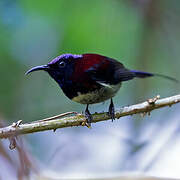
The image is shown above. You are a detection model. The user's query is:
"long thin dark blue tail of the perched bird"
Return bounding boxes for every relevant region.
[131,70,179,83]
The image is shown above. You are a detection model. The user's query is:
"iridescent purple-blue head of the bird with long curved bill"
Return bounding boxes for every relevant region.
[26,54,82,83]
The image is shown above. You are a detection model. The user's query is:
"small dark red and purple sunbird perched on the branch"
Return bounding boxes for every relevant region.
[26,54,177,124]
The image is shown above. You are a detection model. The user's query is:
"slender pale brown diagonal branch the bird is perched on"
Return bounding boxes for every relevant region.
[0,95,180,139]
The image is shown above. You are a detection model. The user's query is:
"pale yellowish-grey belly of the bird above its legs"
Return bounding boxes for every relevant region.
[72,83,121,104]
